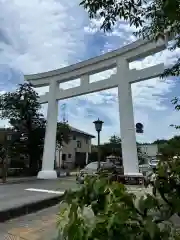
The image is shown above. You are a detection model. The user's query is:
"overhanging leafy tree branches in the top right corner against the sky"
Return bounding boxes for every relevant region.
[80,0,180,76]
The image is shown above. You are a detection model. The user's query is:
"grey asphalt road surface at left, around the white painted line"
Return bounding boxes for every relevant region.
[0,177,78,211]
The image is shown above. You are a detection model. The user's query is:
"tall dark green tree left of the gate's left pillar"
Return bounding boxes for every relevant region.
[0,83,46,175]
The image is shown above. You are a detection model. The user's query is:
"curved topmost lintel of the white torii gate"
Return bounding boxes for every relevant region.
[25,39,166,87]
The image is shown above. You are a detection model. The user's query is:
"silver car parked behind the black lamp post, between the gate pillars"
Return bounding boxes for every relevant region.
[76,162,116,183]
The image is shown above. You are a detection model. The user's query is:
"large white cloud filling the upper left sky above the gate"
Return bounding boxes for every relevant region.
[0,0,86,74]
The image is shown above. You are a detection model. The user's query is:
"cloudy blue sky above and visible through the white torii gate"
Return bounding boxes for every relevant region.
[0,0,180,142]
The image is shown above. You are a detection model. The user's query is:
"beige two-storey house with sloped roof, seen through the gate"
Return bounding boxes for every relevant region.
[56,127,95,169]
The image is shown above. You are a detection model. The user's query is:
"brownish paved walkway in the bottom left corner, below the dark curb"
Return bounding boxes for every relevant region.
[0,205,59,240]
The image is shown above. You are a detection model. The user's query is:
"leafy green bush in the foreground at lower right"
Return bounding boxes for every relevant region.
[58,161,180,240]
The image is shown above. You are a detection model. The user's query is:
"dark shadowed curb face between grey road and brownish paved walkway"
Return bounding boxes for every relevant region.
[0,194,64,223]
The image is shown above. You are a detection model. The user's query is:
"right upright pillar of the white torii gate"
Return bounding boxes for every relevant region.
[117,59,139,174]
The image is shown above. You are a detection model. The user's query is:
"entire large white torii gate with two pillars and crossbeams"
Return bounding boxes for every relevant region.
[25,40,166,179]
